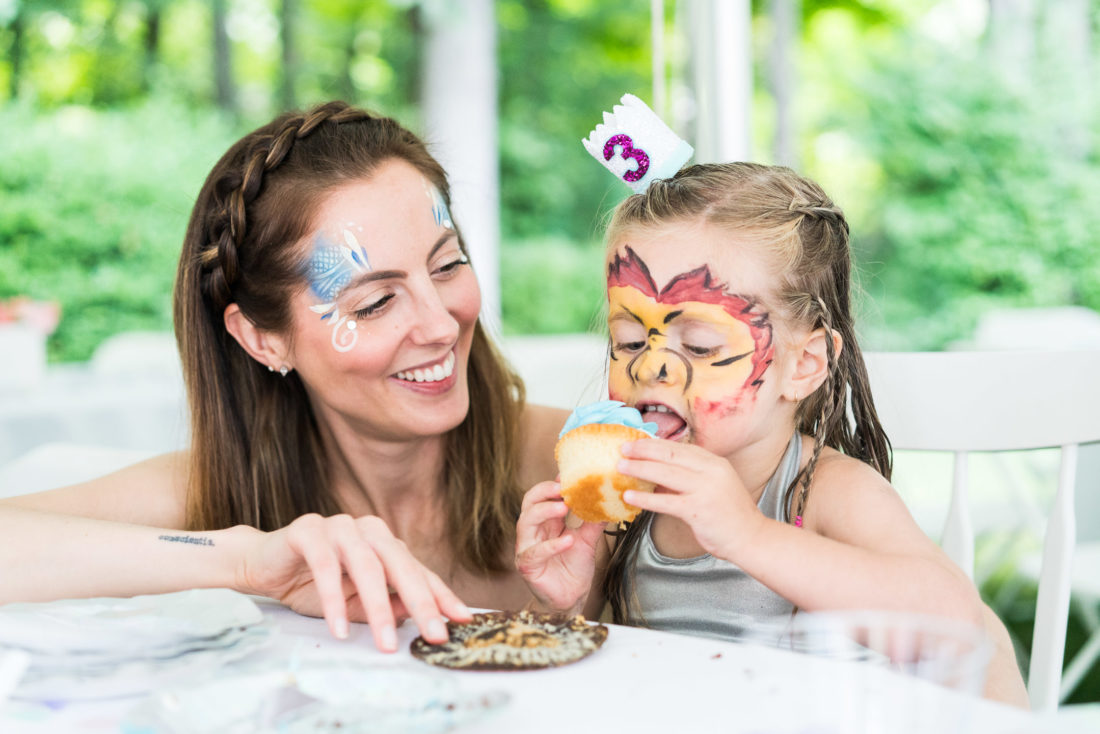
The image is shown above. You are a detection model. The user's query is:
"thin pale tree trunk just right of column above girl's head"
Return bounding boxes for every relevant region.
[768,0,802,168]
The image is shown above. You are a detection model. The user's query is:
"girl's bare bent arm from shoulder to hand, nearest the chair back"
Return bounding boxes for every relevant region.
[619,439,981,624]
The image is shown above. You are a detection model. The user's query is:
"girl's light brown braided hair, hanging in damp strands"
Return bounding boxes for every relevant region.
[604,163,892,622]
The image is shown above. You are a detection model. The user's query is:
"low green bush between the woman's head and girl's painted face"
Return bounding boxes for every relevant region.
[501,240,605,333]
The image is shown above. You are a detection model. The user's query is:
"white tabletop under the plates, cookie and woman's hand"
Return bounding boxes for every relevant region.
[0,600,1069,734]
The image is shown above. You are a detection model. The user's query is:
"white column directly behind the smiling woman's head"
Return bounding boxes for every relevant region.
[421,0,501,333]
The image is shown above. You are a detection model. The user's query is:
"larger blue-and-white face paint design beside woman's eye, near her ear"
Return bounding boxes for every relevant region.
[306,222,371,352]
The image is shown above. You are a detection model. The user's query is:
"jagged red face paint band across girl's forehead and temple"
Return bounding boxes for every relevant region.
[607,247,774,387]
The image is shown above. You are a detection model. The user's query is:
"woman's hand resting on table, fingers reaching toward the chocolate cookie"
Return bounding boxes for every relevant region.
[238,514,471,653]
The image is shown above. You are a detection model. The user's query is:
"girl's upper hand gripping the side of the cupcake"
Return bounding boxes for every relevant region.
[618,438,765,562]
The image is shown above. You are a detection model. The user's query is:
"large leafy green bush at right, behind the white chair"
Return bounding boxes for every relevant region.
[839,40,1100,349]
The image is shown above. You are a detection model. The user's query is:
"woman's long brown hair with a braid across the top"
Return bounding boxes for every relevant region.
[174,102,524,571]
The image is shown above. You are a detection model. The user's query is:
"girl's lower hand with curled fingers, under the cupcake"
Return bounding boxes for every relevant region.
[516,482,604,614]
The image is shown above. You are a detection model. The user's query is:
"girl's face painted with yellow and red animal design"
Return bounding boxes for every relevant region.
[607,222,780,456]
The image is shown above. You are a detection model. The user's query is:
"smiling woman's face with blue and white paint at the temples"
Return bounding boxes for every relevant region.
[287,160,481,440]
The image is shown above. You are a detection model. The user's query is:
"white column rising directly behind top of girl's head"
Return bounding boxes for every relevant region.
[688,0,752,163]
